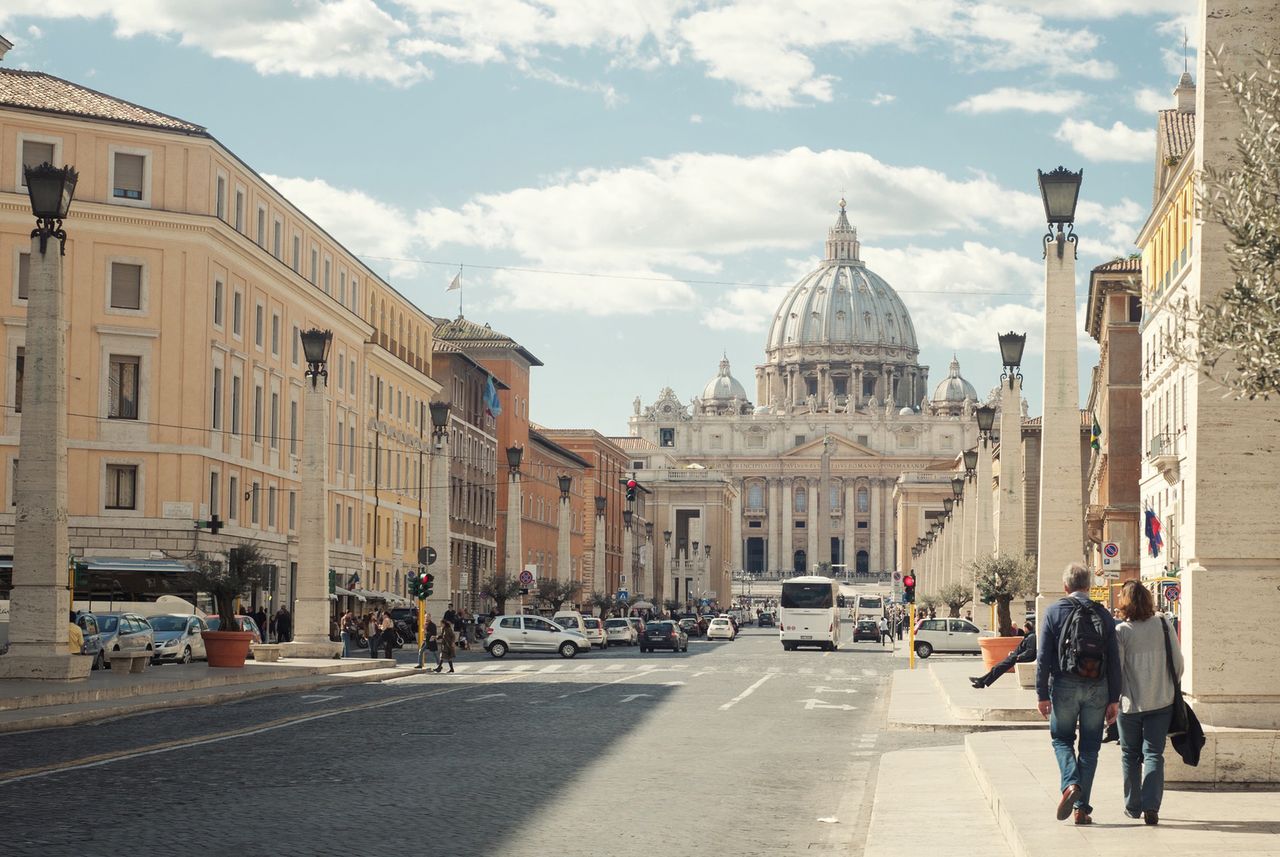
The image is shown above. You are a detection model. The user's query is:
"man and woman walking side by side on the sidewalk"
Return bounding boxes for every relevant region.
[1036,563,1183,825]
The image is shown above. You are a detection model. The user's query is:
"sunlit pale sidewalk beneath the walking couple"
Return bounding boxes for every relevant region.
[965,730,1280,857]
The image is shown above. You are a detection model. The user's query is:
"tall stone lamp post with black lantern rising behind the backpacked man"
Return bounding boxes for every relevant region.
[1034,166,1084,618]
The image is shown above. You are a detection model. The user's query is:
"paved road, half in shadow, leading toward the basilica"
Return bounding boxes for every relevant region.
[0,628,956,857]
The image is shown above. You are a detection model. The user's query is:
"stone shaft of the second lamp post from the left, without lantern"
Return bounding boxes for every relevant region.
[287,375,342,657]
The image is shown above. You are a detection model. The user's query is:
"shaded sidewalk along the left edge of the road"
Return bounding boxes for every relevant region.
[0,657,413,732]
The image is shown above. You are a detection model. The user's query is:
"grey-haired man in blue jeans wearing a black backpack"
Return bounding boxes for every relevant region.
[1036,563,1120,824]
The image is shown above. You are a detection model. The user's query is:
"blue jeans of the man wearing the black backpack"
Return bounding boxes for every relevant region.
[1048,675,1107,812]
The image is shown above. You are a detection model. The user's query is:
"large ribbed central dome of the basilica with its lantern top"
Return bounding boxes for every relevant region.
[765,200,918,362]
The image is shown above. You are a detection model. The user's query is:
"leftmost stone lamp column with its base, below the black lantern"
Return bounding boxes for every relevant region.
[0,238,92,680]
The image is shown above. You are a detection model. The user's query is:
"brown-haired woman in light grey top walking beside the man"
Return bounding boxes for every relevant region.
[1116,581,1183,825]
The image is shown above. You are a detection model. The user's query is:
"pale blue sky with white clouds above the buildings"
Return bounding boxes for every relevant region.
[0,0,1197,435]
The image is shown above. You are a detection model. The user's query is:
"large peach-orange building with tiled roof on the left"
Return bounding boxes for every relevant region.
[0,69,439,613]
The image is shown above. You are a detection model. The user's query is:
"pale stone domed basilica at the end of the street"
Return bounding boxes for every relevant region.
[630,200,978,574]
